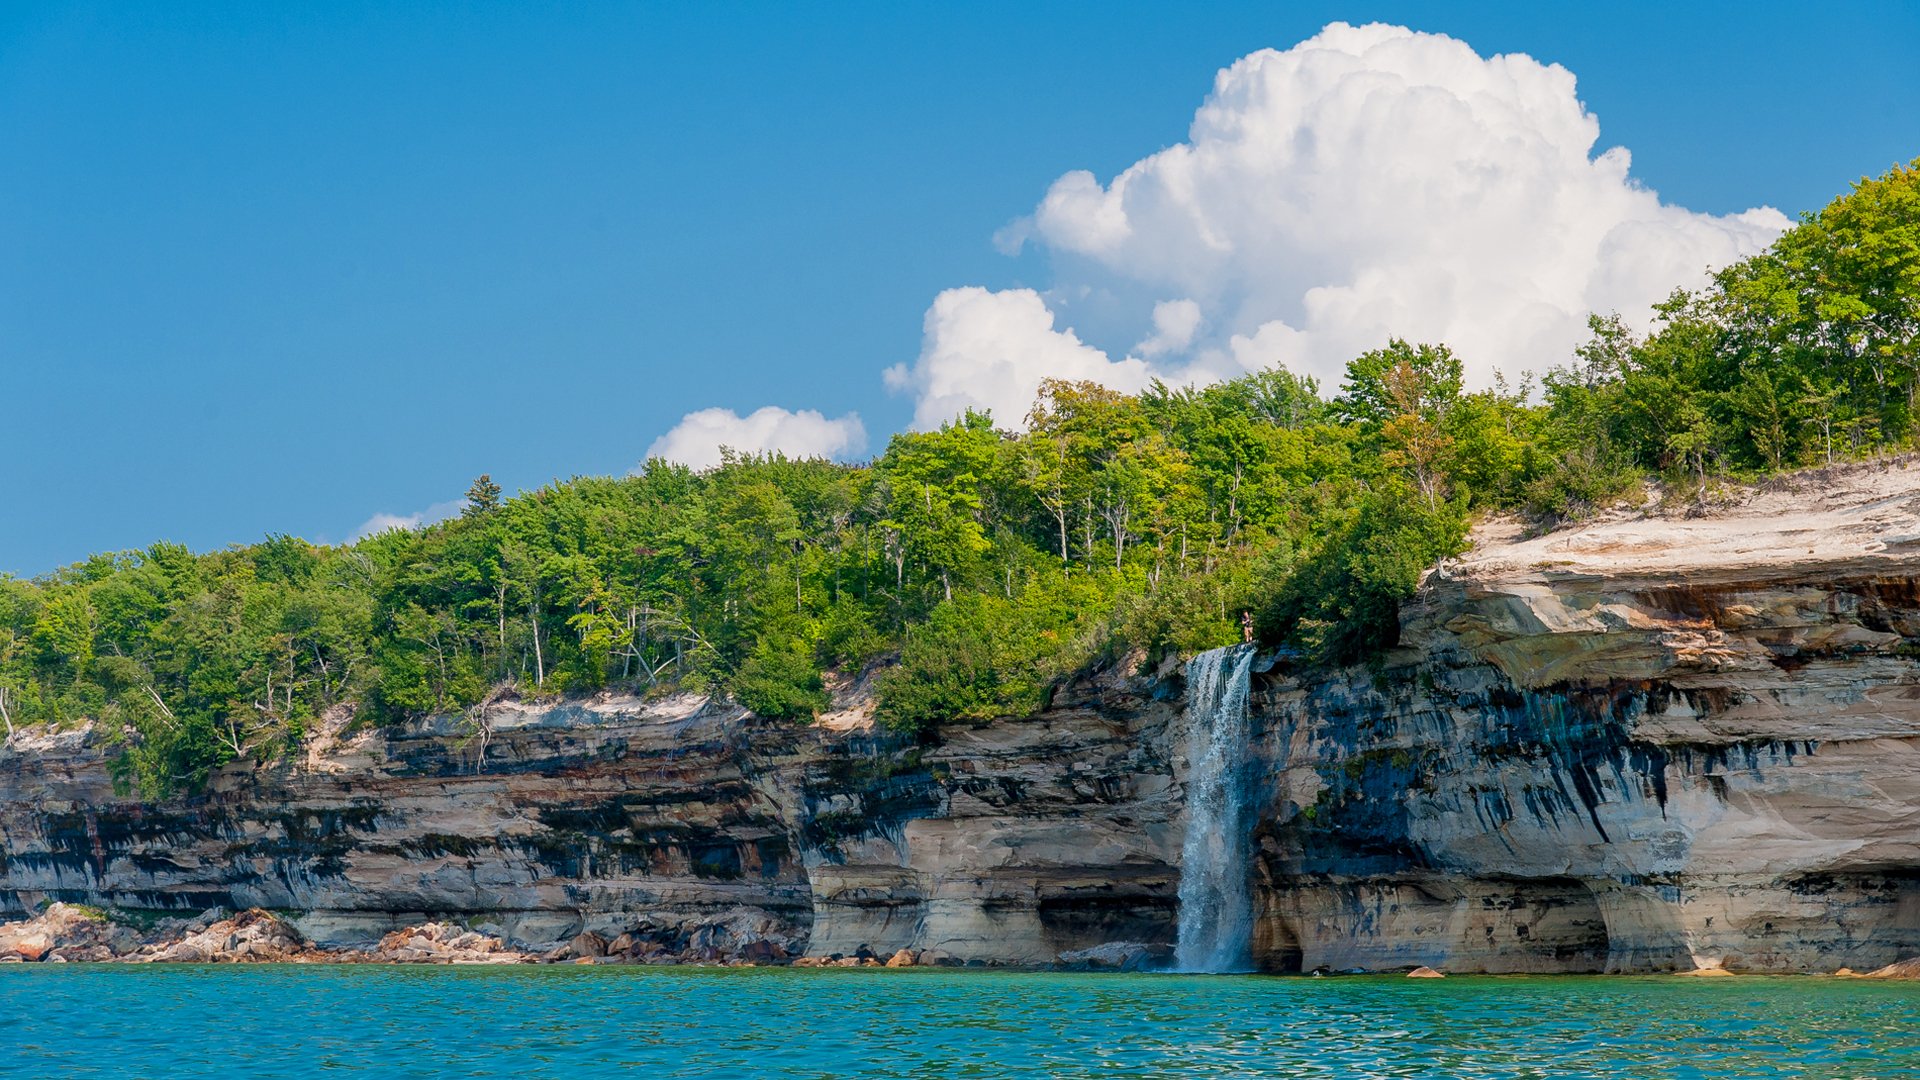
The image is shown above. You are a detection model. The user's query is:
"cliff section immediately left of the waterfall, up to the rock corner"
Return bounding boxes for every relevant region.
[794,678,1185,965]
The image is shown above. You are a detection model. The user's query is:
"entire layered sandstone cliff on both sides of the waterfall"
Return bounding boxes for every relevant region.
[0,467,1920,972]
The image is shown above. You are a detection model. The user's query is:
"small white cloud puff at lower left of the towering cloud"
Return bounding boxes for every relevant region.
[887,286,1152,430]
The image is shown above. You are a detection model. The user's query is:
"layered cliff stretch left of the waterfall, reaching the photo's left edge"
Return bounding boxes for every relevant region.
[0,672,1181,965]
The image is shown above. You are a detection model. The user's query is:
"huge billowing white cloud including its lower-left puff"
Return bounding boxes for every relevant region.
[887,23,1789,427]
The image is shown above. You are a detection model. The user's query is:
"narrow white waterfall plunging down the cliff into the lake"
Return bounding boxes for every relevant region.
[1175,646,1254,972]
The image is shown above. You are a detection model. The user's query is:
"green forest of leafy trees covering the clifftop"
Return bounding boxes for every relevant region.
[0,161,1920,796]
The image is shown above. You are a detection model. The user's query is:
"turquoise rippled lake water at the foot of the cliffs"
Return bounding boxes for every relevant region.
[0,965,1920,1080]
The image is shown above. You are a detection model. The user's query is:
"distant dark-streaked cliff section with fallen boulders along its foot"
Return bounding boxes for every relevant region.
[0,687,840,955]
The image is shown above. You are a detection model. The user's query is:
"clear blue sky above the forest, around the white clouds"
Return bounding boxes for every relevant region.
[0,4,1920,575]
